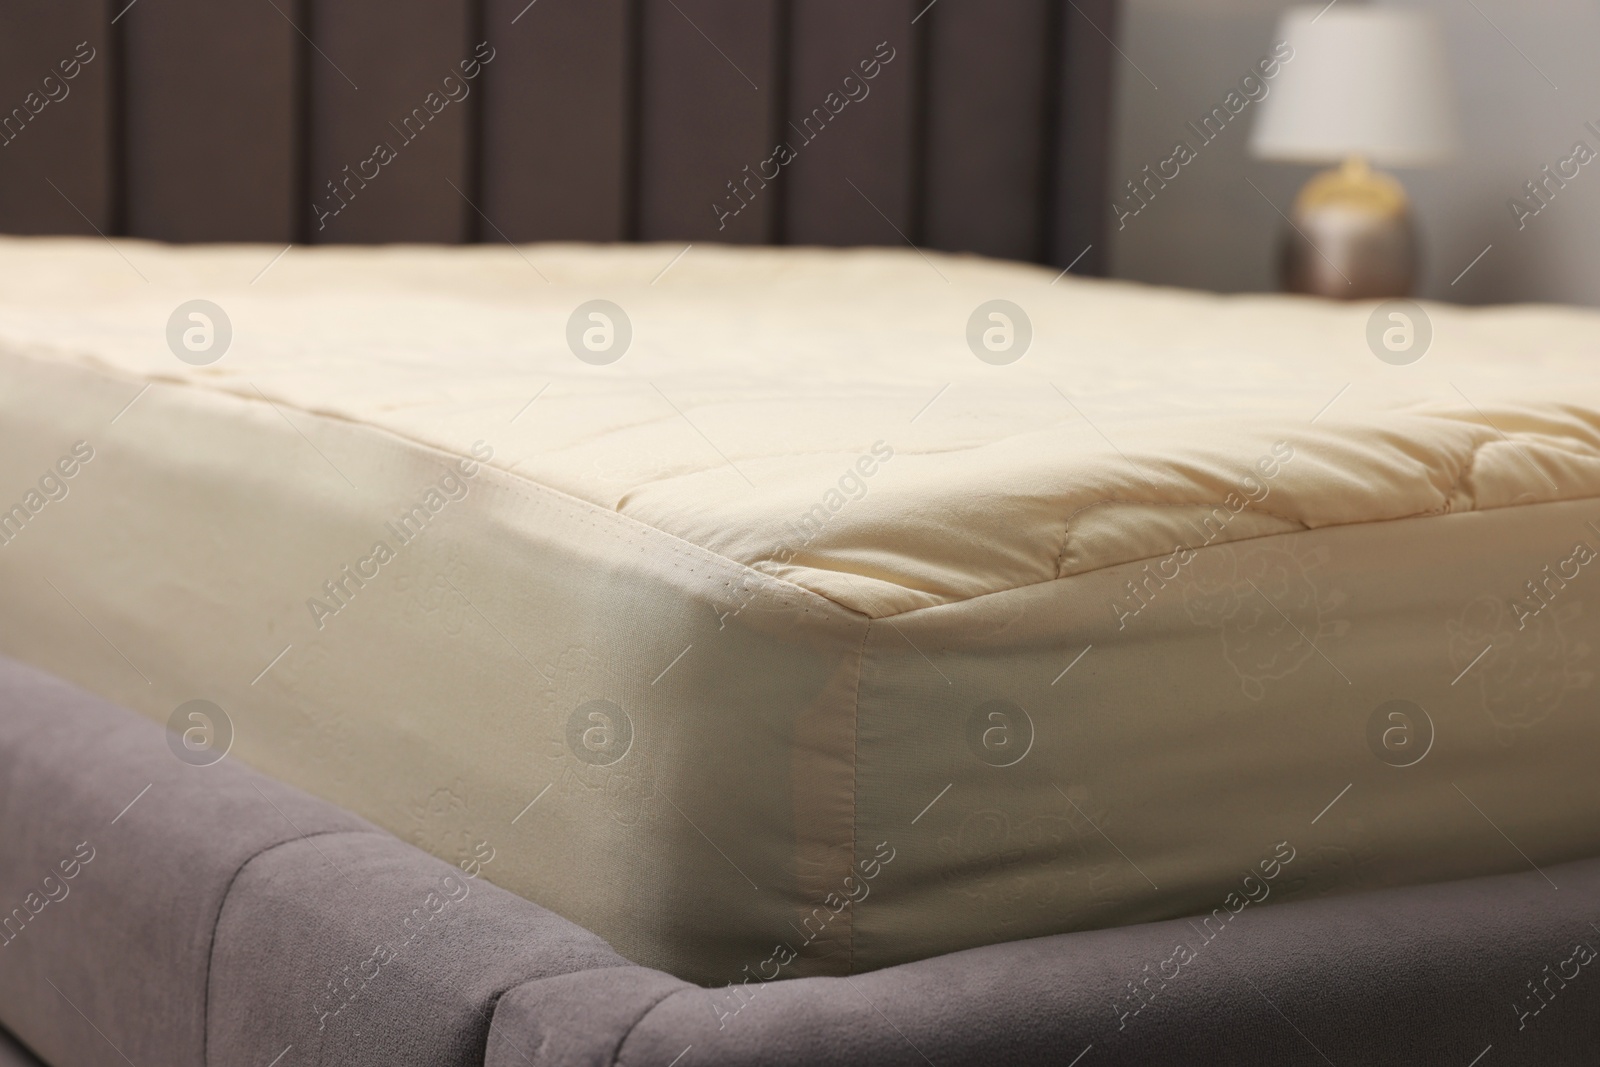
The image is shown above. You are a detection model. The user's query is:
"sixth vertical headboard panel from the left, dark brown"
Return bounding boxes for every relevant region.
[780,0,926,245]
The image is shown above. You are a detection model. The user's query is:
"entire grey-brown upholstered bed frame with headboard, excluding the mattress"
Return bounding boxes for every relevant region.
[9,0,1600,1067]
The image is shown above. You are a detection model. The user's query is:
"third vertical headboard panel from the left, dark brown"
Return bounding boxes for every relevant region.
[302,0,482,243]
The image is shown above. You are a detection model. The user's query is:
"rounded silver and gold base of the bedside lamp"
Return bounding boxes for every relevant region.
[1278,158,1418,301]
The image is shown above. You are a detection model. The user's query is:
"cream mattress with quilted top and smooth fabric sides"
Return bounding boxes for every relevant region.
[0,238,1600,984]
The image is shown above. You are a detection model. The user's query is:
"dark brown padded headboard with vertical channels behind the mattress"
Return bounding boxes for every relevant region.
[0,0,1115,272]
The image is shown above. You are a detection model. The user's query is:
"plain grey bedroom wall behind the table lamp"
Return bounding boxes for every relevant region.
[1106,0,1600,304]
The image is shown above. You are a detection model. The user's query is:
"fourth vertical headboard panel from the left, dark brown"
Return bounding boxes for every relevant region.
[478,0,638,242]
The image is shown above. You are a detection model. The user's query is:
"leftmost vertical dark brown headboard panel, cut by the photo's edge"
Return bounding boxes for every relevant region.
[0,0,115,234]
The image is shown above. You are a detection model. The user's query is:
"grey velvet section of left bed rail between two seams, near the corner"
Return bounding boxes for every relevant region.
[208,833,630,1067]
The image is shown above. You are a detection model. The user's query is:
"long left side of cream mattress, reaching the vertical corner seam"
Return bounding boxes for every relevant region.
[0,357,866,984]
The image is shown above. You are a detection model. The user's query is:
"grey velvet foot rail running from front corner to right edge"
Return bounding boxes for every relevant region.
[488,861,1600,1067]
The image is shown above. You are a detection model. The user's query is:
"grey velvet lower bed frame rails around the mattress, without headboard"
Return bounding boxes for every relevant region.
[0,657,1600,1067]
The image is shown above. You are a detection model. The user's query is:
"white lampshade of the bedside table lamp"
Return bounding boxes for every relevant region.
[1250,3,1456,166]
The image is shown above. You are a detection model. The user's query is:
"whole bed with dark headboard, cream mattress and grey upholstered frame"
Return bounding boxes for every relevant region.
[0,0,1600,1067]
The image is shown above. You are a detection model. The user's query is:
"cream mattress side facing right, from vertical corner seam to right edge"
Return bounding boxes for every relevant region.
[854,501,1600,972]
